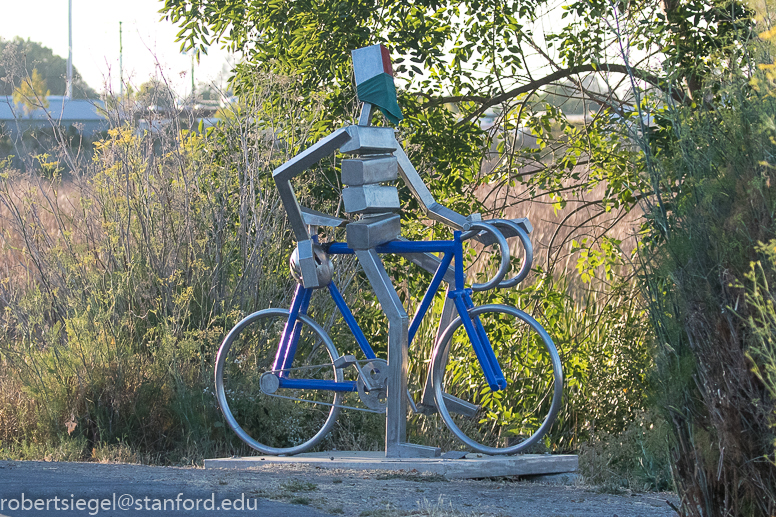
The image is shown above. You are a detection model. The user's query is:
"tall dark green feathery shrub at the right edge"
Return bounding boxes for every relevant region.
[640,74,776,516]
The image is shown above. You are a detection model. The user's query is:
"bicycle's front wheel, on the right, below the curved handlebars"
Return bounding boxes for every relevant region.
[431,305,563,454]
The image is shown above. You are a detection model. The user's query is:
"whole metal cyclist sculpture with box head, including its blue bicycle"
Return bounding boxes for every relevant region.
[216,45,563,457]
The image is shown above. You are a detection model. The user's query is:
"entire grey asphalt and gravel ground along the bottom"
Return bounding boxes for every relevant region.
[0,461,677,517]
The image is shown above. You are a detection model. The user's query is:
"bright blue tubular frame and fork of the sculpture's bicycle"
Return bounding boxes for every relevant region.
[272,231,507,392]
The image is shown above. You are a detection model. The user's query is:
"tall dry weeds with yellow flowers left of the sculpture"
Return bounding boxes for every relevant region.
[0,71,334,463]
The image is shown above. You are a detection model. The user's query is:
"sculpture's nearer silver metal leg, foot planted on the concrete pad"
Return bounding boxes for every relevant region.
[356,249,440,458]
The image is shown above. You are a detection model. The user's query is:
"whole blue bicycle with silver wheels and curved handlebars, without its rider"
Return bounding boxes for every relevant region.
[215,220,563,455]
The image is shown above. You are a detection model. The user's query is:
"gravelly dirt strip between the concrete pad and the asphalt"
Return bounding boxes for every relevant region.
[227,465,678,517]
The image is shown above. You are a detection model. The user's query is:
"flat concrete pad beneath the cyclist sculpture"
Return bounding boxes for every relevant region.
[205,451,578,479]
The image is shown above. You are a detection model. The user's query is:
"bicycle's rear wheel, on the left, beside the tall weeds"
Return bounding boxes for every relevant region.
[215,309,343,455]
